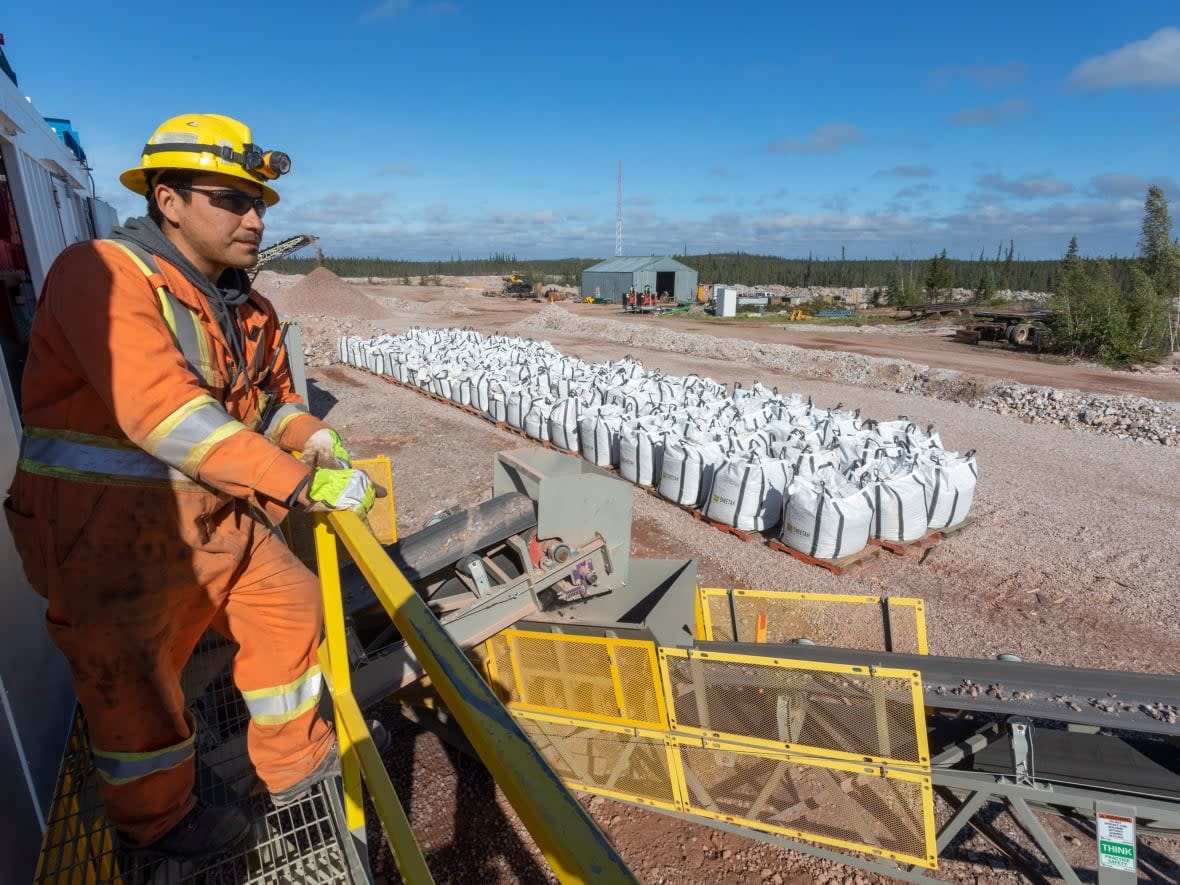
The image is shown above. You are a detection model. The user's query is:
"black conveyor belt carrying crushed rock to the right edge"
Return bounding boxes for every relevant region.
[695,642,1180,736]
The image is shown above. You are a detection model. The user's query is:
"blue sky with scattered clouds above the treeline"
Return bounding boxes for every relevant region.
[0,0,1180,258]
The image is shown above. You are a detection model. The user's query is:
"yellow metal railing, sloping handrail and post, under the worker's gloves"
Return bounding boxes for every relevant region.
[315,512,636,884]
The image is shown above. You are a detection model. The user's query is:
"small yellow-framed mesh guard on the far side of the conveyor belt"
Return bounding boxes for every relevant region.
[696,588,926,655]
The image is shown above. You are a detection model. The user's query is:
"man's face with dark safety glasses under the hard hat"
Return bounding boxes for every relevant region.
[156,173,266,281]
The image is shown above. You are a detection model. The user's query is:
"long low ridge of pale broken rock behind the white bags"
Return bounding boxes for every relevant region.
[511,307,1180,446]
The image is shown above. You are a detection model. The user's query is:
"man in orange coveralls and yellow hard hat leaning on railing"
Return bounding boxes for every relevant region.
[5,114,375,858]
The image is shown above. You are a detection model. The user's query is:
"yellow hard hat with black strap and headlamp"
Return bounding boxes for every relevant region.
[119,113,291,205]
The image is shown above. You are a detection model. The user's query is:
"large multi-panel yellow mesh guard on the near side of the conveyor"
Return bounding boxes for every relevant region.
[483,632,937,868]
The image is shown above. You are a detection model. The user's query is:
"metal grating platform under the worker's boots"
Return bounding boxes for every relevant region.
[33,637,369,885]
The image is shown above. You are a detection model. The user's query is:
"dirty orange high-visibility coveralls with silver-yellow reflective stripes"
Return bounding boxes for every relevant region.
[6,241,334,845]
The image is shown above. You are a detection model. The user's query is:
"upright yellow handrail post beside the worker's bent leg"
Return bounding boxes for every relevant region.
[314,516,365,831]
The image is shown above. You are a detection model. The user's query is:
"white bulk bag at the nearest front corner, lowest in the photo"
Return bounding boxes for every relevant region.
[779,470,873,559]
